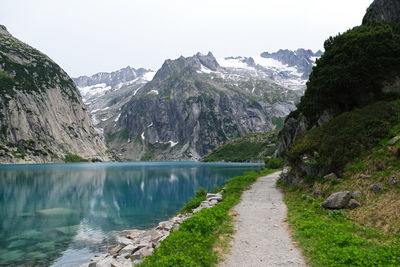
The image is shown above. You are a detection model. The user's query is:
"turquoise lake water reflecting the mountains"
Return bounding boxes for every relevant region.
[0,162,259,267]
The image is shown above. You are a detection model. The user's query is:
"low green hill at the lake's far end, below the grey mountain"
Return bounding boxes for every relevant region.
[202,131,278,162]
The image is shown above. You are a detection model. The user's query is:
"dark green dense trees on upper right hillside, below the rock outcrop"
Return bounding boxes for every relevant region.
[290,23,400,122]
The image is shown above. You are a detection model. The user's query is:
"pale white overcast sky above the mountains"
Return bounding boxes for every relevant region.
[0,0,372,77]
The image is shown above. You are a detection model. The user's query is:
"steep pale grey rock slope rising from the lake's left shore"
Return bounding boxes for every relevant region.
[0,26,107,163]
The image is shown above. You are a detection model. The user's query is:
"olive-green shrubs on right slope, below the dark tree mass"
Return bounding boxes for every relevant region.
[287,100,400,177]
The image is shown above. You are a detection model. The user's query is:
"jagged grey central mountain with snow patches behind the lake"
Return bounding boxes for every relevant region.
[79,50,319,160]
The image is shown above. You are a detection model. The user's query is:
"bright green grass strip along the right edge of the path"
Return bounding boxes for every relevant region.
[283,182,400,266]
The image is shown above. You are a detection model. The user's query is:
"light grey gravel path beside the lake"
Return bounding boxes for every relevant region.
[220,172,306,267]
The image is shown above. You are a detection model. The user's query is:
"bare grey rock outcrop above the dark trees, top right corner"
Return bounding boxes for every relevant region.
[363,0,400,24]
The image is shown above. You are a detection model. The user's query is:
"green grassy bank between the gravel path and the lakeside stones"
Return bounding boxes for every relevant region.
[140,170,276,266]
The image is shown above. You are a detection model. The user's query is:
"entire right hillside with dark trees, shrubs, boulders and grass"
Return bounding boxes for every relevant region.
[276,0,400,266]
